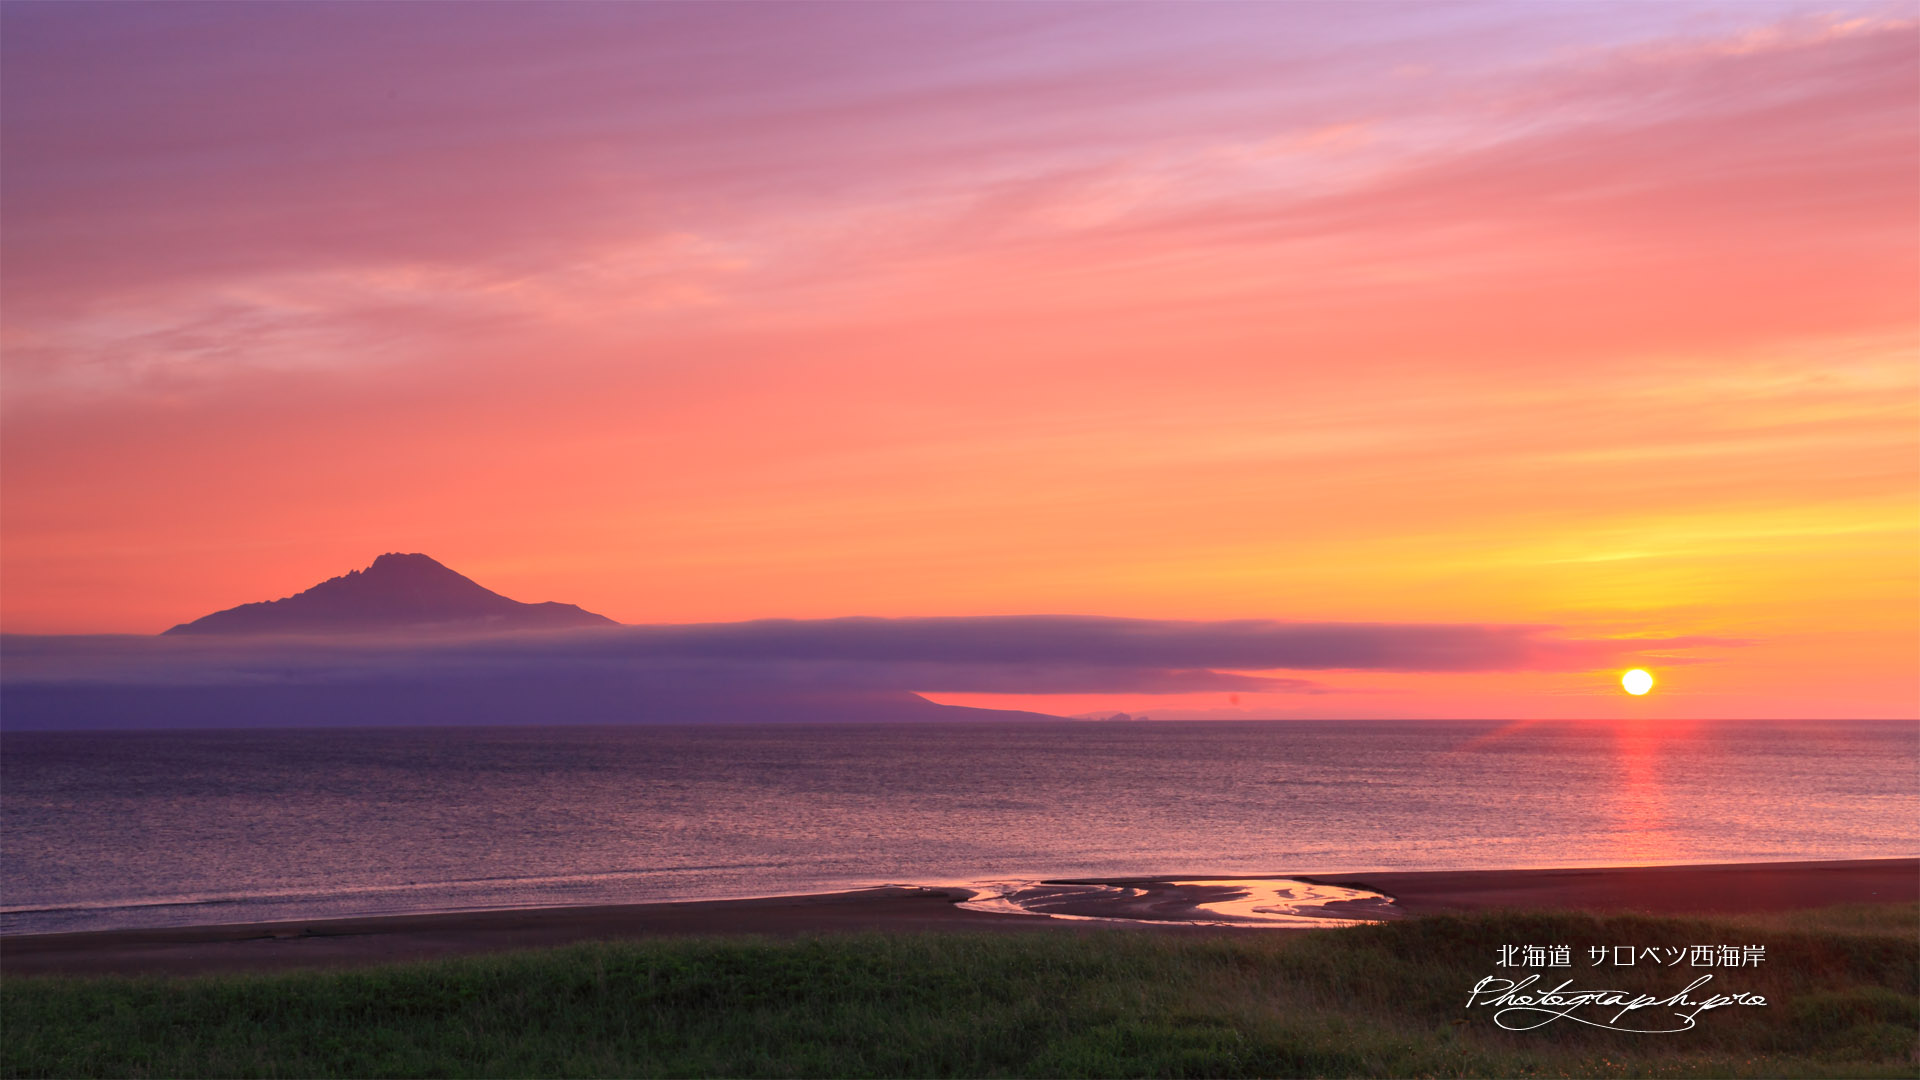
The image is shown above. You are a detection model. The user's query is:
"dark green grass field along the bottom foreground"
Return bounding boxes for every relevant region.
[0,905,1920,1076]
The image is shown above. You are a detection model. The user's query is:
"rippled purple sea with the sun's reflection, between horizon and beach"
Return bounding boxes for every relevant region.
[0,721,1920,934]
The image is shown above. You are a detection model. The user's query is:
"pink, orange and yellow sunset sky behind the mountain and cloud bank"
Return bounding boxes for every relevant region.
[0,2,1920,719]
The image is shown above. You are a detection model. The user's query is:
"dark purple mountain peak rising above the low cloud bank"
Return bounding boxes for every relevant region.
[167,552,618,634]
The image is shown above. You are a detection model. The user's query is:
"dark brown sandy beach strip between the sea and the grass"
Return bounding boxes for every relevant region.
[0,859,1920,974]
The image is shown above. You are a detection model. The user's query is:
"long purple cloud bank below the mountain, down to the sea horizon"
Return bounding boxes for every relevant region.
[0,615,1738,730]
